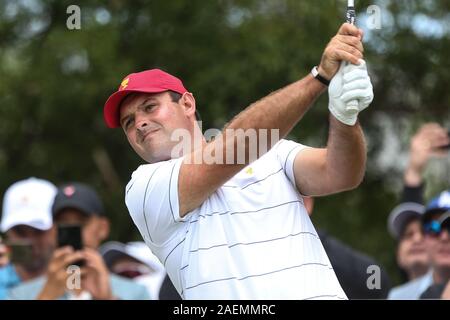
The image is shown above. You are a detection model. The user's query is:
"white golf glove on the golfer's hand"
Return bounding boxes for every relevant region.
[328,59,373,126]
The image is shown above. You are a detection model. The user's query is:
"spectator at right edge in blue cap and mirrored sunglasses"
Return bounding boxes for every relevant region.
[420,195,450,299]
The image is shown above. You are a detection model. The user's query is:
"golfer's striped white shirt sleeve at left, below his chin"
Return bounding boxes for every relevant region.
[125,158,185,246]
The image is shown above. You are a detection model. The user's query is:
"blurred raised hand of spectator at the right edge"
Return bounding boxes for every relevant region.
[405,123,450,186]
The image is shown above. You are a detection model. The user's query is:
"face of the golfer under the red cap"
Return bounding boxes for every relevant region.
[120,92,195,163]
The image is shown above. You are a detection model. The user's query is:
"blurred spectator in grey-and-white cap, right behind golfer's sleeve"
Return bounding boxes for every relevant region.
[99,241,166,300]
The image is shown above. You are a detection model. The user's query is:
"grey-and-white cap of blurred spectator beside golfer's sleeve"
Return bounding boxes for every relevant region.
[99,241,164,272]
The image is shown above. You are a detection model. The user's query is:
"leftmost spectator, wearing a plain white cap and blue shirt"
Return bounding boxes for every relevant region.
[0,178,56,299]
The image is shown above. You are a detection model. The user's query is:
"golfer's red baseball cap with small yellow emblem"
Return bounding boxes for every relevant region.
[103,69,187,128]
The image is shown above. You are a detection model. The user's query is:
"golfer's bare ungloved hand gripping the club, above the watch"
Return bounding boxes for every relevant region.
[318,23,364,80]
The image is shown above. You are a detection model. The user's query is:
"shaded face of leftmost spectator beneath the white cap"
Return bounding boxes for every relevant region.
[6,225,56,272]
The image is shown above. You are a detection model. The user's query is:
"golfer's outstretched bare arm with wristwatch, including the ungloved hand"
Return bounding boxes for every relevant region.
[178,24,362,217]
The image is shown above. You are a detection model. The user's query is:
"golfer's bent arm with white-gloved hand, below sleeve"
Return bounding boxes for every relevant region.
[294,54,373,196]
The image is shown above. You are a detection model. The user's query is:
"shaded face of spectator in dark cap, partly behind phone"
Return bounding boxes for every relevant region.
[55,208,109,249]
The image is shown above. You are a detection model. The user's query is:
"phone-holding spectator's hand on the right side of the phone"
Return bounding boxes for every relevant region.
[81,248,114,300]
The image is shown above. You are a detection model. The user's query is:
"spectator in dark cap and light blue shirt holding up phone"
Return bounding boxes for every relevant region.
[8,183,149,300]
